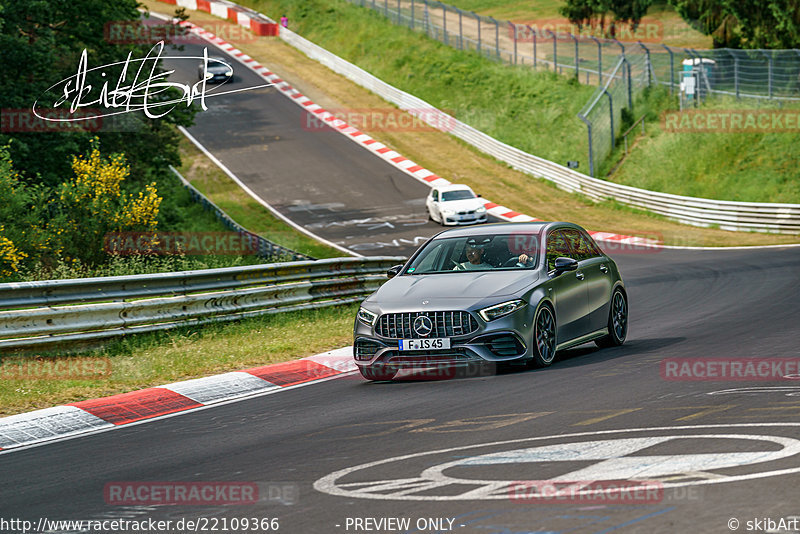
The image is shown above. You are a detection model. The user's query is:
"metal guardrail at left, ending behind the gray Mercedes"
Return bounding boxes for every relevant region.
[0,256,405,350]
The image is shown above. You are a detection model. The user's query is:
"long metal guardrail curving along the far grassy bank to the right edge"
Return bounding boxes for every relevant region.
[280,28,800,234]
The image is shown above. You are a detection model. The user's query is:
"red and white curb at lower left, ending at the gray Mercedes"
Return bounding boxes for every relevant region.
[0,347,357,451]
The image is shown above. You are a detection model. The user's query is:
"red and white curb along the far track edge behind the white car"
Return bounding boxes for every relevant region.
[169,16,658,247]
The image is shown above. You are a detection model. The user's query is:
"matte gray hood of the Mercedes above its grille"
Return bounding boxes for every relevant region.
[365,271,538,311]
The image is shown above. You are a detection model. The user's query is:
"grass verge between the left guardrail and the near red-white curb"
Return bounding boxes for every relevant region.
[0,304,358,416]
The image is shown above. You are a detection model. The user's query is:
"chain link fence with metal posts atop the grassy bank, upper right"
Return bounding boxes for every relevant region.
[348,0,800,176]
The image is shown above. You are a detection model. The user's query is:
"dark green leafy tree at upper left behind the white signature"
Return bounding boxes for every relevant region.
[0,0,194,186]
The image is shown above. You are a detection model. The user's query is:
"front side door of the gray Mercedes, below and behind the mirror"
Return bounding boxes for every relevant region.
[545,230,589,343]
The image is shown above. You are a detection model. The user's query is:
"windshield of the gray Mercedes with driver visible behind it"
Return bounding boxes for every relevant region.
[405,232,539,275]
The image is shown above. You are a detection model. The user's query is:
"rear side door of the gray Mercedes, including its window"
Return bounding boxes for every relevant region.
[564,229,614,332]
